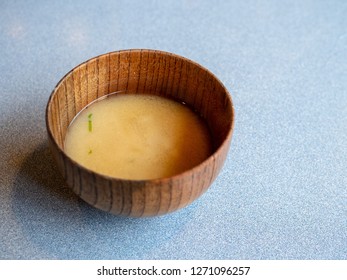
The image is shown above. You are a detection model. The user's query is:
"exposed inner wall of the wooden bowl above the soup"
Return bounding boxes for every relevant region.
[46,50,233,155]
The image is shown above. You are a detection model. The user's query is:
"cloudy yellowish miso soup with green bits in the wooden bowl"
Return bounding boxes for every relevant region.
[64,94,212,180]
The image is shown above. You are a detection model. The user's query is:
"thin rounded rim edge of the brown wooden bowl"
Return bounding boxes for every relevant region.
[45,48,235,184]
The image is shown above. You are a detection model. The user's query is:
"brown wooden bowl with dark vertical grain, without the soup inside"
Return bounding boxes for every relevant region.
[46,49,234,217]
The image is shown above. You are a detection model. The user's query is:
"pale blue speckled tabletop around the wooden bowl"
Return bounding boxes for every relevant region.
[0,0,347,259]
